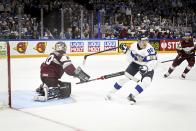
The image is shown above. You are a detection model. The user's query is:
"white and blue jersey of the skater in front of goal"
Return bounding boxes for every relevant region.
[126,42,157,71]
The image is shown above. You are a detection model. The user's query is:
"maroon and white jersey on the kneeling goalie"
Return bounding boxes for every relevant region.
[40,51,74,79]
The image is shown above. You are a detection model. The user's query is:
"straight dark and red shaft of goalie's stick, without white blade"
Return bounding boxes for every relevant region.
[76,71,125,84]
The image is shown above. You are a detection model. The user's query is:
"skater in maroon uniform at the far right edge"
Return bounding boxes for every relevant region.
[164,35,196,79]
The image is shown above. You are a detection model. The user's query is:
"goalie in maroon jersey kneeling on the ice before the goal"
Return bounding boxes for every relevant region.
[34,42,90,101]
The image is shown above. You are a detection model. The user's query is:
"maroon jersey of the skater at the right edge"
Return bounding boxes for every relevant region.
[177,39,195,58]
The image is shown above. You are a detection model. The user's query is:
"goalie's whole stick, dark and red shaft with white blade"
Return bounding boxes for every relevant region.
[76,71,140,84]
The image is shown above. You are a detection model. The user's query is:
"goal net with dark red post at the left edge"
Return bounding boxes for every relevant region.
[0,41,11,109]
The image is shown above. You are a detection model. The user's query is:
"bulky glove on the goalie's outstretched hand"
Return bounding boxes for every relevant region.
[75,67,90,82]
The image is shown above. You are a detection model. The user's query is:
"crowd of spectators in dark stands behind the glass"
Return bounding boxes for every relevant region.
[0,0,196,39]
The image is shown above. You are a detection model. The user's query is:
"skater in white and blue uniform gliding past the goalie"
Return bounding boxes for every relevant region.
[106,38,157,104]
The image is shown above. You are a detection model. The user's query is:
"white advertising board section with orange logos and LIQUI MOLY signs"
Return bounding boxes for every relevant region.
[9,40,118,58]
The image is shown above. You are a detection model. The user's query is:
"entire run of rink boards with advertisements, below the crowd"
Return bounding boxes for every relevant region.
[4,39,193,58]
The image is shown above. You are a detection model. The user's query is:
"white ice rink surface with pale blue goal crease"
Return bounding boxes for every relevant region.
[0,54,196,131]
